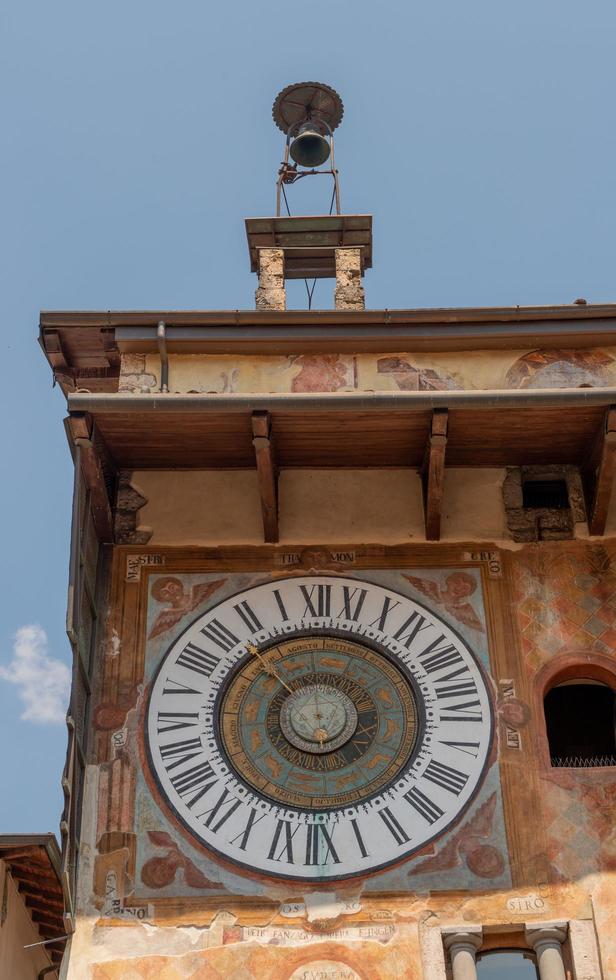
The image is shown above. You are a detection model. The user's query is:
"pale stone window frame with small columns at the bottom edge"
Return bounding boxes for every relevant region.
[421,918,603,980]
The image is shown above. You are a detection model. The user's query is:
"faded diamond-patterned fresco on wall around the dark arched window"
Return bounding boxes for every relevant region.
[513,540,616,956]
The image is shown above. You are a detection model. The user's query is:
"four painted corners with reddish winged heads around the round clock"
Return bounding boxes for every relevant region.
[119,568,510,900]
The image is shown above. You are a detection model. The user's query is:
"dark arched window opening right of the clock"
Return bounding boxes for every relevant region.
[544,678,616,768]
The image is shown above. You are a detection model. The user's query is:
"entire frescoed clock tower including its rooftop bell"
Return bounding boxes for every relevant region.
[41,82,616,980]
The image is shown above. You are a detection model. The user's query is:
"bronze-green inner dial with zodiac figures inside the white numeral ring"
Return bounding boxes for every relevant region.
[220,636,417,810]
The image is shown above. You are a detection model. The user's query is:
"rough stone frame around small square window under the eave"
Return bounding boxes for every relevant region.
[503,463,587,543]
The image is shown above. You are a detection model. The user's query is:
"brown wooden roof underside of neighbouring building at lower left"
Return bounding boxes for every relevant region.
[0,834,66,966]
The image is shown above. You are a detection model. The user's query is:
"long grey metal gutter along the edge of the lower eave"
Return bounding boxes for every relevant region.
[68,388,616,413]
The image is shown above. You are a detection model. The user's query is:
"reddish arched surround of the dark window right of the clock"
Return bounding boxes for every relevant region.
[533,650,616,778]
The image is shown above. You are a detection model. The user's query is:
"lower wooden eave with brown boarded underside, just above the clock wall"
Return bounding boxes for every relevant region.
[68,388,616,469]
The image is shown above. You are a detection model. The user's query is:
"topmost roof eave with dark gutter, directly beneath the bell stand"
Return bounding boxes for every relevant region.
[40,304,616,392]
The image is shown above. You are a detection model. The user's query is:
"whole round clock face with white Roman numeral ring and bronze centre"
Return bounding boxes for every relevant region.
[146,576,492,881]
